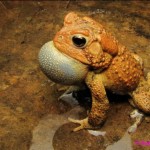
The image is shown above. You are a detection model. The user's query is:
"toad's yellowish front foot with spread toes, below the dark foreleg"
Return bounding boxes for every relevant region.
[68,118,93,131]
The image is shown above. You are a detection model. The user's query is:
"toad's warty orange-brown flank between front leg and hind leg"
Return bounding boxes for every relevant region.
[105,47,143,94]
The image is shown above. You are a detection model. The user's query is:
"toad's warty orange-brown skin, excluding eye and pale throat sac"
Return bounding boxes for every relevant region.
[53,12,150,130]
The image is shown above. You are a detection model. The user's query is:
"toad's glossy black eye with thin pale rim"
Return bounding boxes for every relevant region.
[72,36,86,47]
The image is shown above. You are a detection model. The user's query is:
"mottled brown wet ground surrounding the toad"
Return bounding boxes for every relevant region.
[0,1,150,150]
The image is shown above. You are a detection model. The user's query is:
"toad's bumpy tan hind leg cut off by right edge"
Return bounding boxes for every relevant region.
[130,77,150,114]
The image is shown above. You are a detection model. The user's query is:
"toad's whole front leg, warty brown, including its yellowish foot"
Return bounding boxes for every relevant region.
[69,72,109,131]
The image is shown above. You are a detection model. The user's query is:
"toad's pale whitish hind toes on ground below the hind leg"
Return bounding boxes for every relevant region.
[128,110,144,133]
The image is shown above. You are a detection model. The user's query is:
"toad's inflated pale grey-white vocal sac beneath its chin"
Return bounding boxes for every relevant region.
[39,41,88,85]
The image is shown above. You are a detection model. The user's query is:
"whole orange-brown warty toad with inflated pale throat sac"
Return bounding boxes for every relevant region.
[39,12,150,131]
